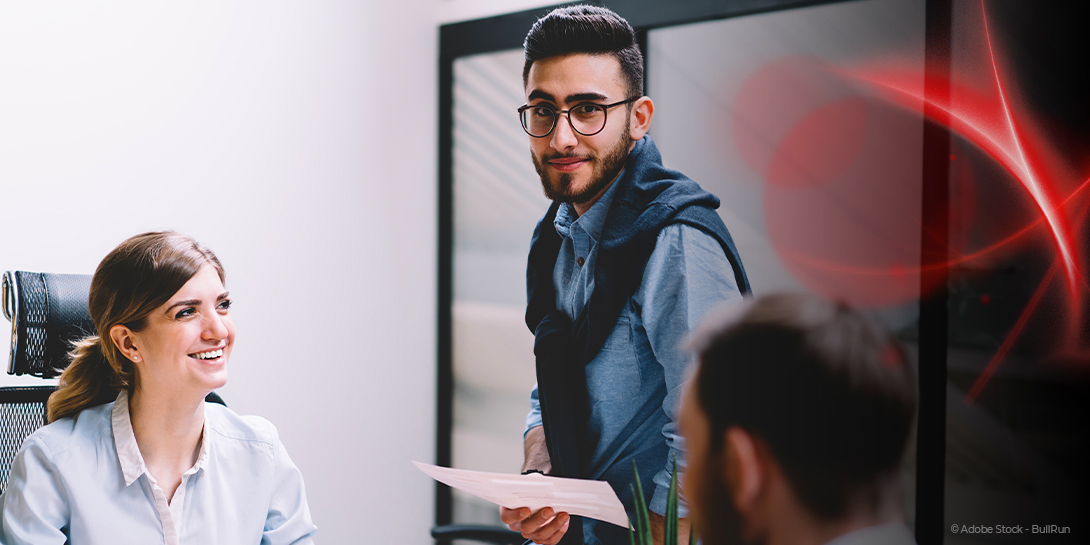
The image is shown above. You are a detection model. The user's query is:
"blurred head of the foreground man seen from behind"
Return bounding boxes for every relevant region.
[681,294,916,545]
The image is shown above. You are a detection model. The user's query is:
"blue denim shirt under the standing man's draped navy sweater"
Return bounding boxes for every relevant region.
[526,177,741,517]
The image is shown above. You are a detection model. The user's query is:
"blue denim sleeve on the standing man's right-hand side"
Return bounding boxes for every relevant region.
[634,225,742,517]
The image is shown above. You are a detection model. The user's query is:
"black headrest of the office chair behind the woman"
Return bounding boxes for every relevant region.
[3,270,95,378]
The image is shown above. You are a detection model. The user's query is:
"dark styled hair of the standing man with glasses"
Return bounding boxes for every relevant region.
[522,5,643,98]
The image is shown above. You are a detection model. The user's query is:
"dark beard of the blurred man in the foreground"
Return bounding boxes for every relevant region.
[690,449,764,545]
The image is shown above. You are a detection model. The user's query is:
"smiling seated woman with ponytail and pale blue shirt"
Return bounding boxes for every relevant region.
[0,231,316,545]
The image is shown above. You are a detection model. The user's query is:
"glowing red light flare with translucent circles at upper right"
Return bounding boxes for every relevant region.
[731,2,1090,402]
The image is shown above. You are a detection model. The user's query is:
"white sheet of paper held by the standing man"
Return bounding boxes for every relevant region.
[412,462,629,528]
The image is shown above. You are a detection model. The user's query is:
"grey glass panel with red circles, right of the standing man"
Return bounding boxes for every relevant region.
[647,1,924,525]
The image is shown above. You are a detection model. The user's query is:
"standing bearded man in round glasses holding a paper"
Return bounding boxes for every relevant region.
[500,5,749,545]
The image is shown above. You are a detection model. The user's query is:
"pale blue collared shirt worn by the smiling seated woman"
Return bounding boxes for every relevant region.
[0,391,315,545]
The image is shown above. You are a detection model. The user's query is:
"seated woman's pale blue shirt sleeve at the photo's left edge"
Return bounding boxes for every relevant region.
[0,436,69,545]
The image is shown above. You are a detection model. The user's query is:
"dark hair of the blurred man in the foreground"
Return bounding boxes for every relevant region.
[694,293,917,520]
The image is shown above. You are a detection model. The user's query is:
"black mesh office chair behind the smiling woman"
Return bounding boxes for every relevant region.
[0,270,227,493]
